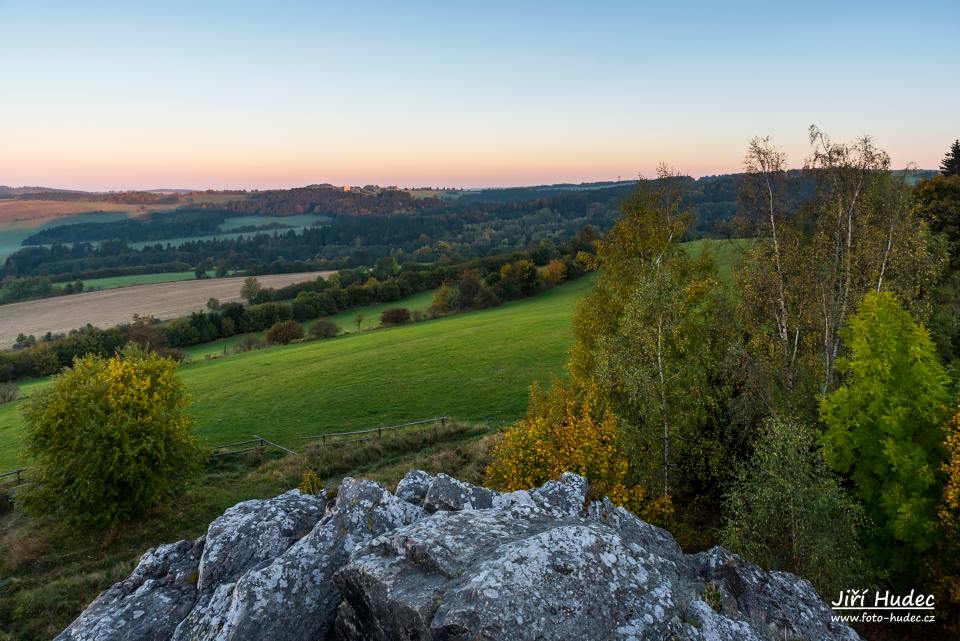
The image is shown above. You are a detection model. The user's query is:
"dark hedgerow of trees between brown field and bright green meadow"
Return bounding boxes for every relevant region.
[0,235,596,382]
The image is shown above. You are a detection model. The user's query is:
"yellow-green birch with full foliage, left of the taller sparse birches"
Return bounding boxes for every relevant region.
[570,167,732,496]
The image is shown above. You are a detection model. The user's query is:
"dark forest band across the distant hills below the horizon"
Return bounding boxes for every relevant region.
[0,172,811,292]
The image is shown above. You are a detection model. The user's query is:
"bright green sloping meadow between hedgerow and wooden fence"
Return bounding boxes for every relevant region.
[0,277,592,470]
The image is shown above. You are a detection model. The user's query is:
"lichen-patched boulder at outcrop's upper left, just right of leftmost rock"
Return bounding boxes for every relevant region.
[197,490,326,593]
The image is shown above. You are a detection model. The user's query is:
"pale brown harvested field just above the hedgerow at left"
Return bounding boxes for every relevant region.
[0,272,332,348]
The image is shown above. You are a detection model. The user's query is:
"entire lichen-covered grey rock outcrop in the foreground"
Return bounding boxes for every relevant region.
[57,471,859,641]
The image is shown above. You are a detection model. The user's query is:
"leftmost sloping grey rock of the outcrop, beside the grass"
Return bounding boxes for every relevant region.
[55,539,203,641]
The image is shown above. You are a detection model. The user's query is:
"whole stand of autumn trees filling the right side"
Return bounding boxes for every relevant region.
[487,134,960,633]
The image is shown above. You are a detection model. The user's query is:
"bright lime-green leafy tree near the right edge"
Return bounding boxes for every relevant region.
[821,292,949,558]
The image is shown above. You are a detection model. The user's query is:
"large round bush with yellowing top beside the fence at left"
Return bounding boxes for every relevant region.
[23,345,203,523]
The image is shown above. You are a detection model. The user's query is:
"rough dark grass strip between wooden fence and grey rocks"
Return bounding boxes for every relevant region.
[0,424,492,641]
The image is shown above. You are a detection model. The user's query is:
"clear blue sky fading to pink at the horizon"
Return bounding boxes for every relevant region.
[0,0,960,190]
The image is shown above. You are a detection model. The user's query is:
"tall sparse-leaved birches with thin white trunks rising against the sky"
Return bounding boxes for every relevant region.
[737,127,943,416]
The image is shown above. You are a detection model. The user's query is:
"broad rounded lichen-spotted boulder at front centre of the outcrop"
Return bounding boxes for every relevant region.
[335,505,682,641]
